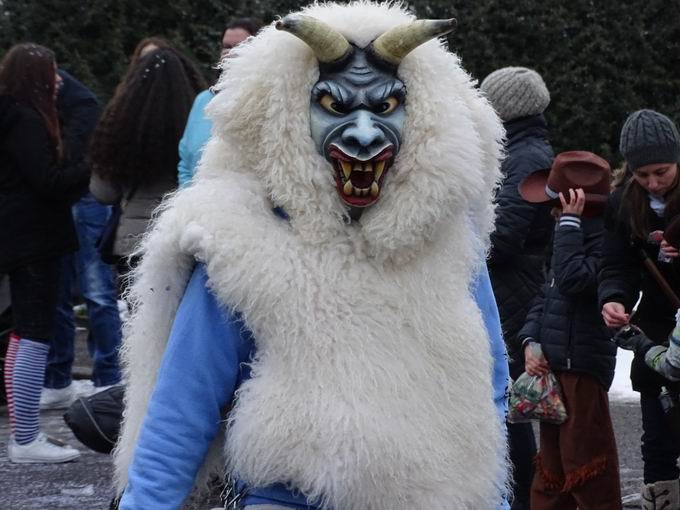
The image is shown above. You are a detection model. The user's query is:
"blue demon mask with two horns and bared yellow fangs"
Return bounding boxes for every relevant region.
[276,15,455,211]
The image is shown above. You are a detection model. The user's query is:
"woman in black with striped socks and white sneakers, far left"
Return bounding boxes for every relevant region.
[0,44,88,463]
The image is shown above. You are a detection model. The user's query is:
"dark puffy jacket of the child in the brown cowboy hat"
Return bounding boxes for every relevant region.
[519,215,616,390]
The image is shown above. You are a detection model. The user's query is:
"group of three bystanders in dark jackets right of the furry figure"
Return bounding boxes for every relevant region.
[481,68,680,509]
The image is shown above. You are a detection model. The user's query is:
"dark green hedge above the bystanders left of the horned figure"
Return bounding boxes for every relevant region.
[0,0,235,98]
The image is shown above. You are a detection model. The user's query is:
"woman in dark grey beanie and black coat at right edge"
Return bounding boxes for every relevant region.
[599,110,680,508]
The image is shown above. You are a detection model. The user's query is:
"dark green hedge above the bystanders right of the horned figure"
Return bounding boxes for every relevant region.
[440,0,680,161]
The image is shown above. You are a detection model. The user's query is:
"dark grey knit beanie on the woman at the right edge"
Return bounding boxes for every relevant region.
[619,110,680,170]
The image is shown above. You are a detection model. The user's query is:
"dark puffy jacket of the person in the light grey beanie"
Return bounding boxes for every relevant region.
[488,115,554,358]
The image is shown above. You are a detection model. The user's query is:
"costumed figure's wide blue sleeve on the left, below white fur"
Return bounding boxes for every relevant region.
[120,265,252,510]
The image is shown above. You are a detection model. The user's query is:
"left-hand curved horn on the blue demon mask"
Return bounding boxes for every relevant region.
[276,14,352,64]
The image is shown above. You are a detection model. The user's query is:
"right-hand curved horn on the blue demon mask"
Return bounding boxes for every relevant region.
[371,18,458,66]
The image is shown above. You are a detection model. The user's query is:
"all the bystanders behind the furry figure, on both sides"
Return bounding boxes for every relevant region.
[0,6,680,510]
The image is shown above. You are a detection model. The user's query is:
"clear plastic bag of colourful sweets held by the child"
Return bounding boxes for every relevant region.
[508,372,567,425]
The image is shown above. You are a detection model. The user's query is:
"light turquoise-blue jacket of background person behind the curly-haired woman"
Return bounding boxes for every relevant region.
[177,90,213,187]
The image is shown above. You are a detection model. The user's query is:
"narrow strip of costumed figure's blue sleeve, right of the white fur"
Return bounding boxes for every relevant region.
[472,265,510,510]
